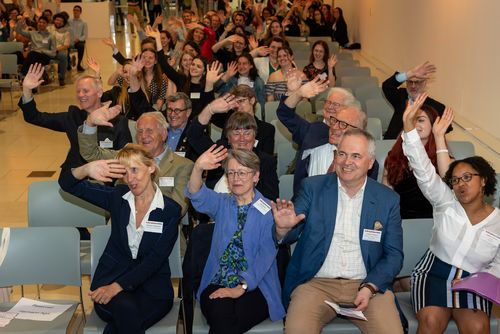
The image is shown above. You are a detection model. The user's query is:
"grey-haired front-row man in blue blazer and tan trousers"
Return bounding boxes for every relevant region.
[273,129,403,334]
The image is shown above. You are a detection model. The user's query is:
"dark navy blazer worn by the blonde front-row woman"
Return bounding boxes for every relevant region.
[59,170,181,300]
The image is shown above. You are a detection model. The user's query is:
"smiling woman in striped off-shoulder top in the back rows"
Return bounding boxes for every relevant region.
[266,46,307,101]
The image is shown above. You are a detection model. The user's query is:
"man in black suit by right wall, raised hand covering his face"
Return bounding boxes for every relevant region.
[382,62,445,139]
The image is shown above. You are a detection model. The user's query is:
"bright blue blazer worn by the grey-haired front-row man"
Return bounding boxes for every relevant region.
[283,173,403,306]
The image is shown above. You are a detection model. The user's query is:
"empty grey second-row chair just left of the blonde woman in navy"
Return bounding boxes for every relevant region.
[28,181,106,275]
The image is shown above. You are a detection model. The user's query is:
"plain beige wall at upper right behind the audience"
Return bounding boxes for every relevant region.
[350,0,500,140]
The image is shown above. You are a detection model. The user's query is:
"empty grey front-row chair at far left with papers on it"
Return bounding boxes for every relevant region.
[0,226,85,334]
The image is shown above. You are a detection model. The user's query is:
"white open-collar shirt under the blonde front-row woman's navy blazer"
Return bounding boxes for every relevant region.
[122,184,165,260]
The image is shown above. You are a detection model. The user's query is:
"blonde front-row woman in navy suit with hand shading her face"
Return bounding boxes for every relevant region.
[59,144,181,333]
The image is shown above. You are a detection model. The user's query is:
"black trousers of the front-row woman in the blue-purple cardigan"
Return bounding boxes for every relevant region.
[200,284,269,334]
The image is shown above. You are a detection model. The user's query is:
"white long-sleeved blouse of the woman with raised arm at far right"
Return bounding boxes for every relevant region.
[402,130,500,277]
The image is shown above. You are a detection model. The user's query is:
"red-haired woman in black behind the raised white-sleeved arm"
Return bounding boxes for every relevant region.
[382,105,453,219]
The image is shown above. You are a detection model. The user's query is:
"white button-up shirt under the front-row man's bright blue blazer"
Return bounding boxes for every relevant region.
[316,179,366,279]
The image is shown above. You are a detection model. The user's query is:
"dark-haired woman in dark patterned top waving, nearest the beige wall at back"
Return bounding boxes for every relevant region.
[303,41,337,87]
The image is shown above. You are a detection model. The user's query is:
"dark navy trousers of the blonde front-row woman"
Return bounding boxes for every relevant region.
[94,291,173,334]
